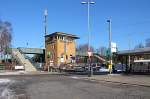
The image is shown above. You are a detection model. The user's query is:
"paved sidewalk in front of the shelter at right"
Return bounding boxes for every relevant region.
[81,74,150,87]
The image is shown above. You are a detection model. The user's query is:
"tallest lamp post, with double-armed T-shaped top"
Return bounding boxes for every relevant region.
[81,0,95,77]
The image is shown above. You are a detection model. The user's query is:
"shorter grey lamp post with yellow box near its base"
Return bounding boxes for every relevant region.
[107,19,112,74]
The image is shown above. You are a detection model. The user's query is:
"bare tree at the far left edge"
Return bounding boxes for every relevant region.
[0,20,12,61]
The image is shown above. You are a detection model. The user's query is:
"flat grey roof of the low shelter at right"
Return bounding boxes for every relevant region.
[117,47,150,55]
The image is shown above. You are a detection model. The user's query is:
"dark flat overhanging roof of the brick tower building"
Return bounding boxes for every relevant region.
[45,32,79,39]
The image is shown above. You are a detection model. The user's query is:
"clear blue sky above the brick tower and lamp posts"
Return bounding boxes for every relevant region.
[0,0,150,50]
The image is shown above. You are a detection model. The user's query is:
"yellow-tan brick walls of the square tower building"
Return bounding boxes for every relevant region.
[45,35,76,67]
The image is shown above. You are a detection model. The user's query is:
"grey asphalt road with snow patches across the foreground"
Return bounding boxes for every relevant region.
[0,75,150,99]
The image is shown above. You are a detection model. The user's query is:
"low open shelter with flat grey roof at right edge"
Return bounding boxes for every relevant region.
[116,47,150,73]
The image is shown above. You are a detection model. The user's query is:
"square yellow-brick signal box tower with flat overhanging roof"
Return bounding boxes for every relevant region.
[45,32,79,68]
